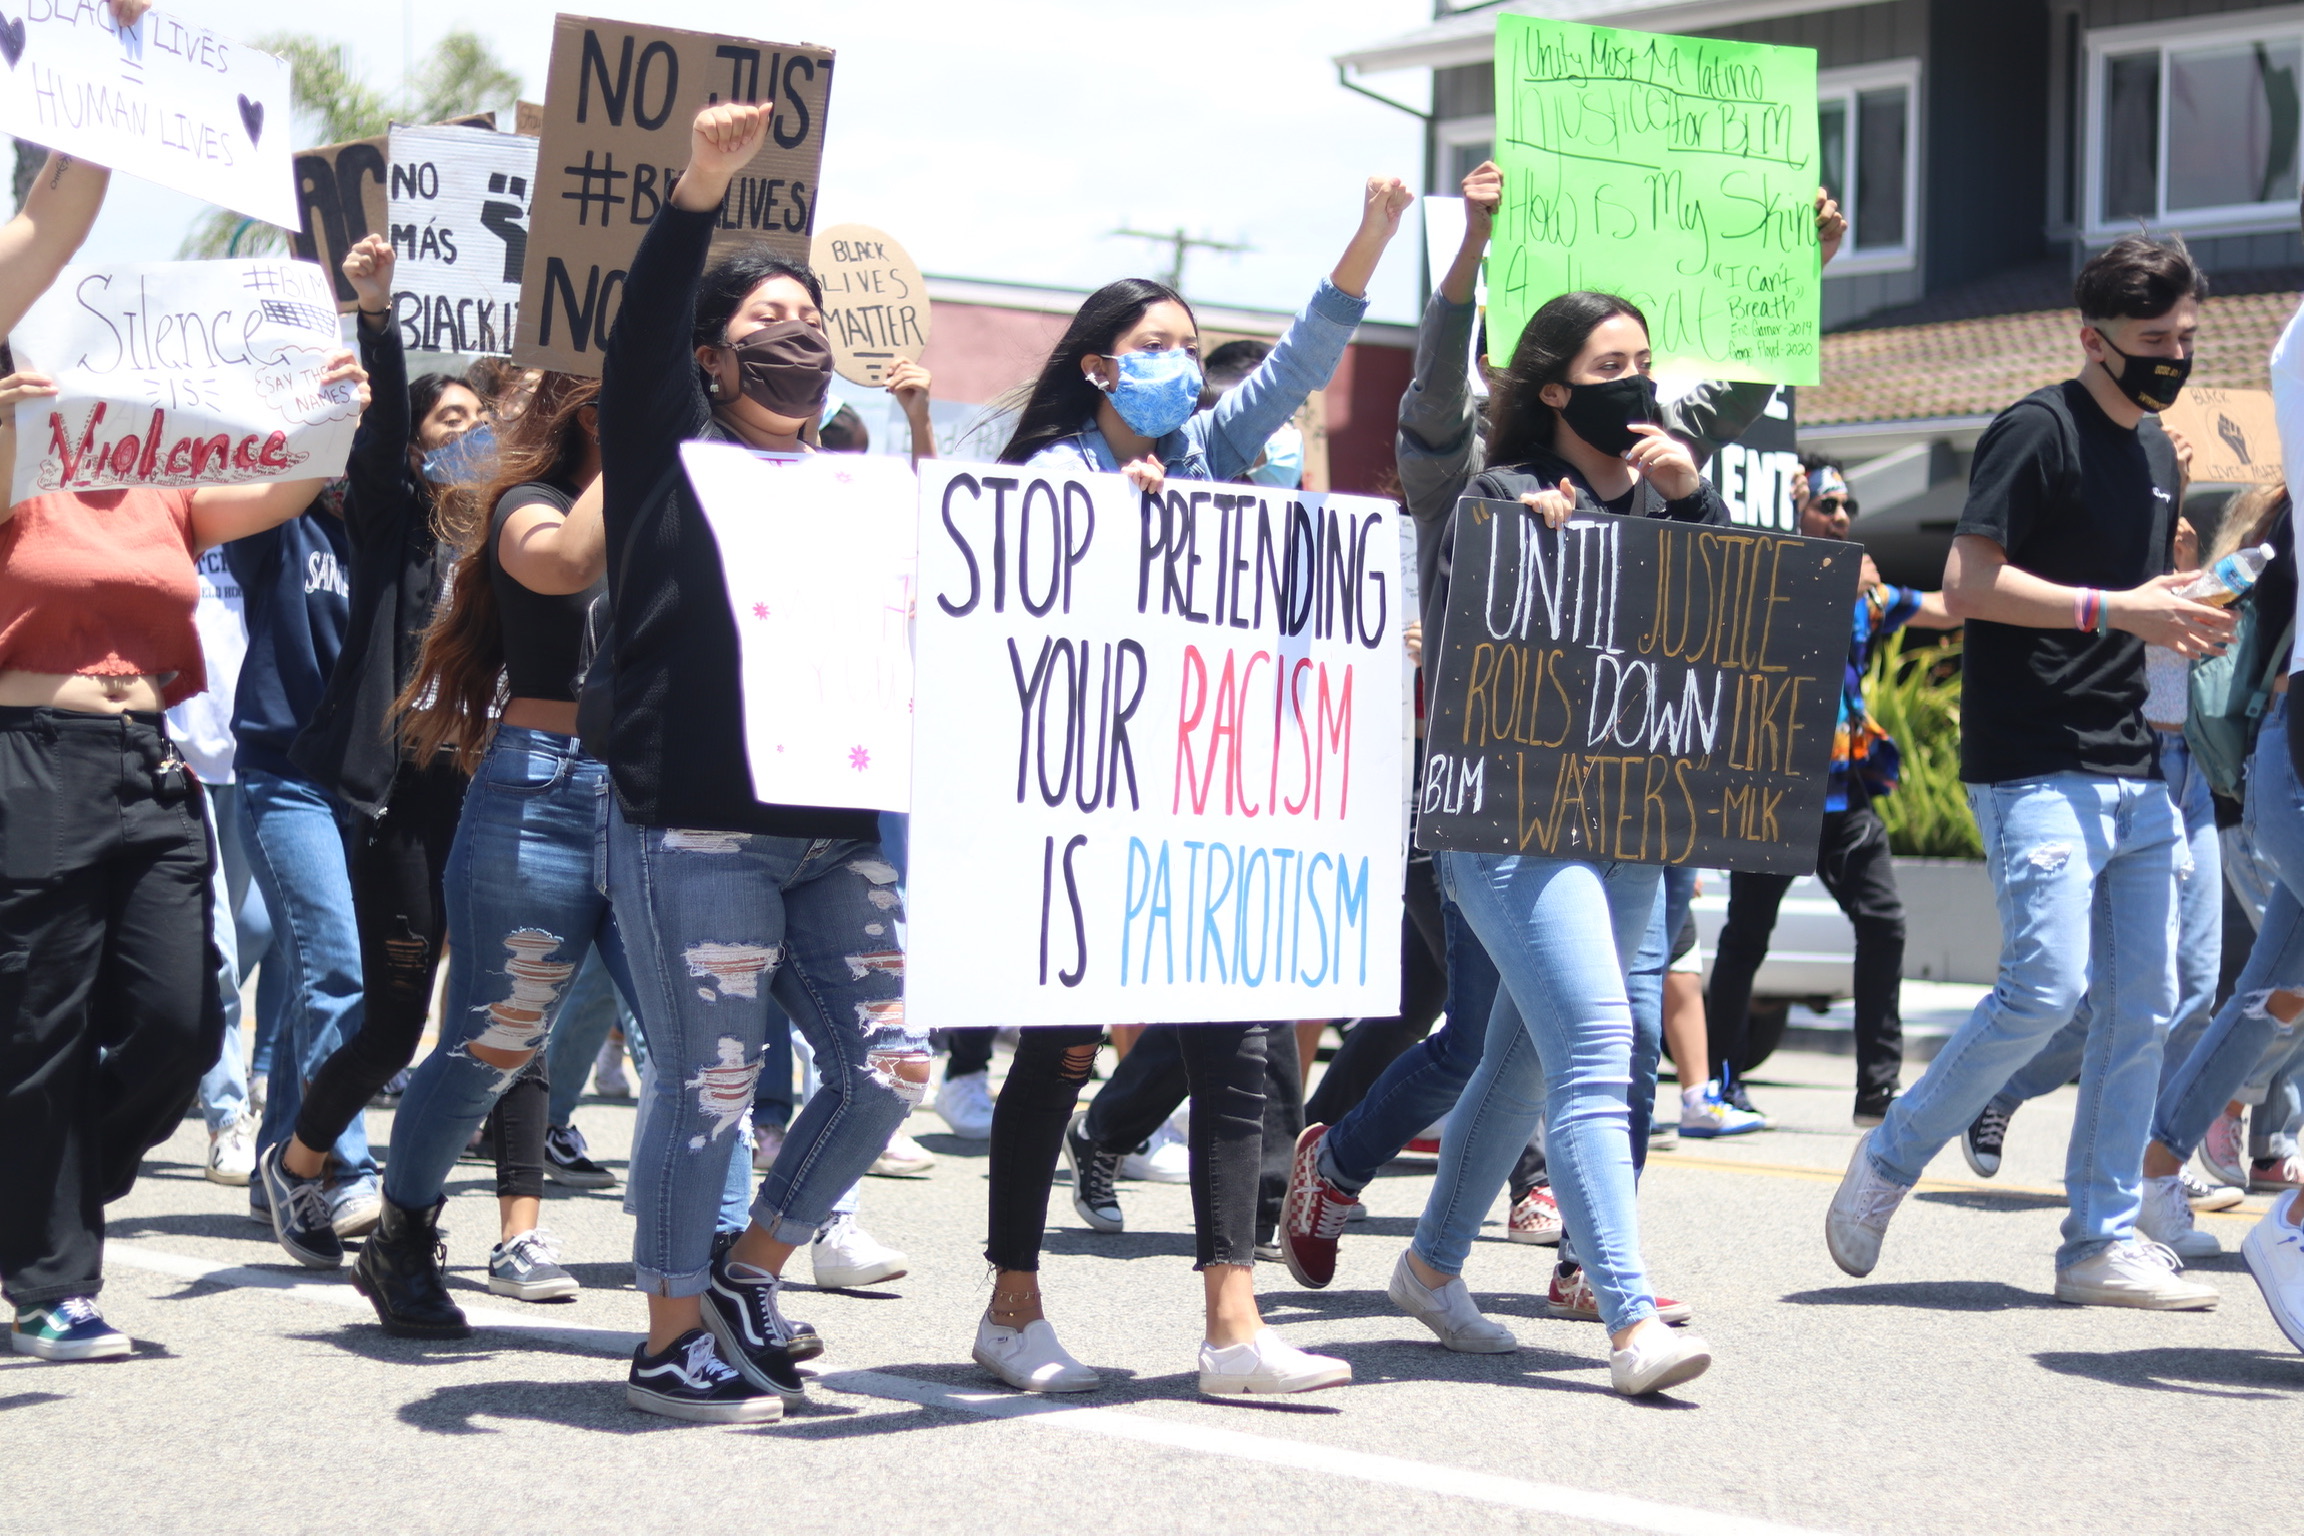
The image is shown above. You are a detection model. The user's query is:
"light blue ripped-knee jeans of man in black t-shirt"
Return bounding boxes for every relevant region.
[1869,774,2184,1269]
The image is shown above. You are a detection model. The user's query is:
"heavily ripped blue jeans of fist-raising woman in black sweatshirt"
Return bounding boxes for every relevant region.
[606,801,929,1297]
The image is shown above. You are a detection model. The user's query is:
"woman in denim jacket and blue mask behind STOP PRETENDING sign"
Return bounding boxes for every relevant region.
[975,177,1415,1393]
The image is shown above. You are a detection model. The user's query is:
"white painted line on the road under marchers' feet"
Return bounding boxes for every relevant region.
[104,1244,1852,1536]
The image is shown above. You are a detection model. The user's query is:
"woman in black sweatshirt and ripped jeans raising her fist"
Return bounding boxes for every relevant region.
[599,101,929,1423]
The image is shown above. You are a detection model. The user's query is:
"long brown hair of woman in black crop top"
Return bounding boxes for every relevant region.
[392,373,599,774]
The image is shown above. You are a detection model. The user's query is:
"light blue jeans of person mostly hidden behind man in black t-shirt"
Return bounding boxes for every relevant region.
[1993,730,2223,1112]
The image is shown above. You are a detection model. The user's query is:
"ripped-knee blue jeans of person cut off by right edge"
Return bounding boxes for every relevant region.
[2152,693,2304,1158]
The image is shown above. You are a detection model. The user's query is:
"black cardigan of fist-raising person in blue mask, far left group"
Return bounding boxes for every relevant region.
[288,320,447,815]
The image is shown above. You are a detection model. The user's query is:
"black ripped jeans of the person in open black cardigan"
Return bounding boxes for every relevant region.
[295,758,470,1151]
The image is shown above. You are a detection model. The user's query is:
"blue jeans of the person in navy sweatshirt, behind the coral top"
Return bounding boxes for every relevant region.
[240,769,376,1181]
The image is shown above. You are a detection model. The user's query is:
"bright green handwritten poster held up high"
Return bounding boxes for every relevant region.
[1488,16,1822,385]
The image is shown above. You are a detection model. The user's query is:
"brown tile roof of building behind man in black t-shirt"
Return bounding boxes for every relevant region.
[1799,265,2304,426]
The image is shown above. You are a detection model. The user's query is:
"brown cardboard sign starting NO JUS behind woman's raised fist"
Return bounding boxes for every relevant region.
[511,16,834,375]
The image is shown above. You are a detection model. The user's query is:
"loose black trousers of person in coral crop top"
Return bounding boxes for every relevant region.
[0,707,223,1308]
